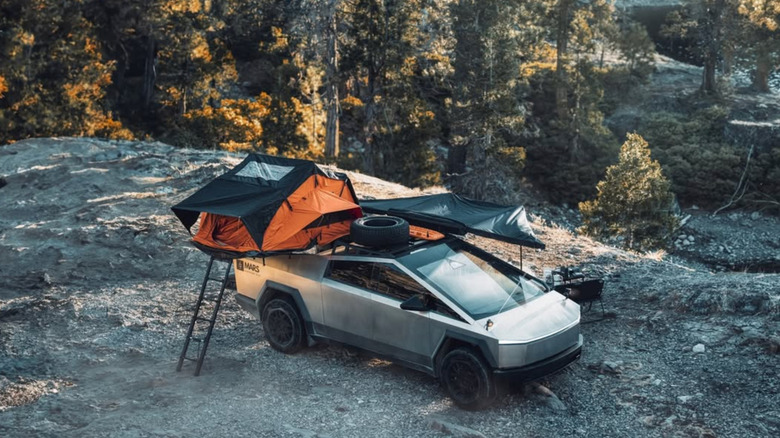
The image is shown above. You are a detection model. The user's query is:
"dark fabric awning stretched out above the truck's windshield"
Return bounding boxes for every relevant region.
[360,193,544,248]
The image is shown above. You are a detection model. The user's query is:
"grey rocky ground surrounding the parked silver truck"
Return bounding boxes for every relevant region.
[0,139,780,437]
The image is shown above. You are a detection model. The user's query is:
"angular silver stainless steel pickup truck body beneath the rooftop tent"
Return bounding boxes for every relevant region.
[234,237,583,408]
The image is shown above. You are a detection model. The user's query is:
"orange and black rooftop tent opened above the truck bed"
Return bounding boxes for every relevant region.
[172,154,362,253]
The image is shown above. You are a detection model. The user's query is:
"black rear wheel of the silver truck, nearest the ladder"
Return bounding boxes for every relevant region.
[263,297,305,354]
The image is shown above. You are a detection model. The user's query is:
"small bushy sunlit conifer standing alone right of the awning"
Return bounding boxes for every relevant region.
[579,133,677,250]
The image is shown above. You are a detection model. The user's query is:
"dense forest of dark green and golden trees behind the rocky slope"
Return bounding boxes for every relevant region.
[0,0,780,216]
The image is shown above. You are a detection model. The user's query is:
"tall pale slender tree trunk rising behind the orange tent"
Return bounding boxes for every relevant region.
[325,1,341,158]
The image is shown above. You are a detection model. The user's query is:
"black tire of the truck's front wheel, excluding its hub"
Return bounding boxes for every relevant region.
[439,348,496,410]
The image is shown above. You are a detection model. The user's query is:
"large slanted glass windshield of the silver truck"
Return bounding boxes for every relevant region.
[401,240,544,319]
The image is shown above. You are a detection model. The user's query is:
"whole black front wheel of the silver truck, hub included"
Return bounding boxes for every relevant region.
[439,348,496,410]
